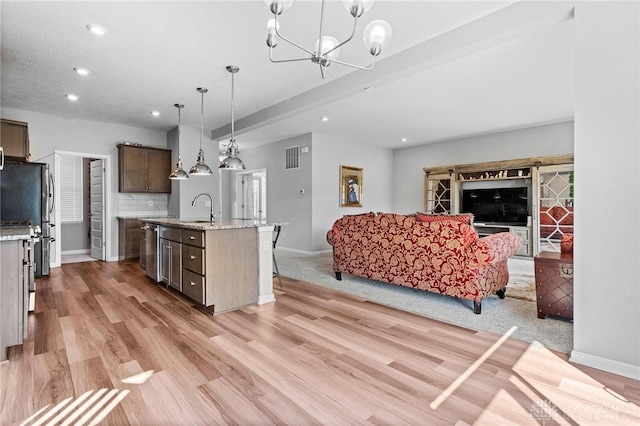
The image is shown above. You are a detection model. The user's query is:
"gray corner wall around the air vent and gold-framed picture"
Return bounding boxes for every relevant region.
[241,133,393,252]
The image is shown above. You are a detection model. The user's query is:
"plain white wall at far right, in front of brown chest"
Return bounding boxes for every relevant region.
[571,2,640,379]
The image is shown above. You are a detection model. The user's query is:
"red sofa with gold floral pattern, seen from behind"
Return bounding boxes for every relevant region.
[327,213,522,314]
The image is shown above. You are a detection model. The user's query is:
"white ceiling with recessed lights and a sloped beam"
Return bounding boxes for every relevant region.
[0,0,574,150]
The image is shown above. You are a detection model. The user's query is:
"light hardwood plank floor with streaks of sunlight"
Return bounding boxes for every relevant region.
[0,262,640,425]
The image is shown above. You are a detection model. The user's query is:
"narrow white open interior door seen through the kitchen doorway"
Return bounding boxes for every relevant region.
[89,160,105,260]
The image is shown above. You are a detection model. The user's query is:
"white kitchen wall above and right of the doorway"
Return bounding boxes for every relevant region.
[1,108,166,260]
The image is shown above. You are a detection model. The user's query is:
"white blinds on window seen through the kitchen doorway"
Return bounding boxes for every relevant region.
[60,155,84,223]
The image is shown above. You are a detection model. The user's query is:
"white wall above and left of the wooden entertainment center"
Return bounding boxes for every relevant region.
[392,121,574,213]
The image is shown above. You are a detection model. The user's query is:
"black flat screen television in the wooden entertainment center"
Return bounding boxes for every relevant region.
[461,188,529,226]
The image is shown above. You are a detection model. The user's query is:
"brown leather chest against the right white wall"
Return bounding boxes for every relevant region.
[533,251,573,320]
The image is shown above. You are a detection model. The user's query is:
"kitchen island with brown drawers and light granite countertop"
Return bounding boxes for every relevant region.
[140,217,277,314]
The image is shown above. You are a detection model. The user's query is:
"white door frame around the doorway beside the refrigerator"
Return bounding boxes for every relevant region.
[51,150,110,267]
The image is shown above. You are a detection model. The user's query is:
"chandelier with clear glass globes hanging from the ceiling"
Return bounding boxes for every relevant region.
[264,0,391,78]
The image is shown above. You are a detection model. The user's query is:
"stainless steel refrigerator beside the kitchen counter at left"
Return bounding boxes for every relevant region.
[0,163,54,278]
